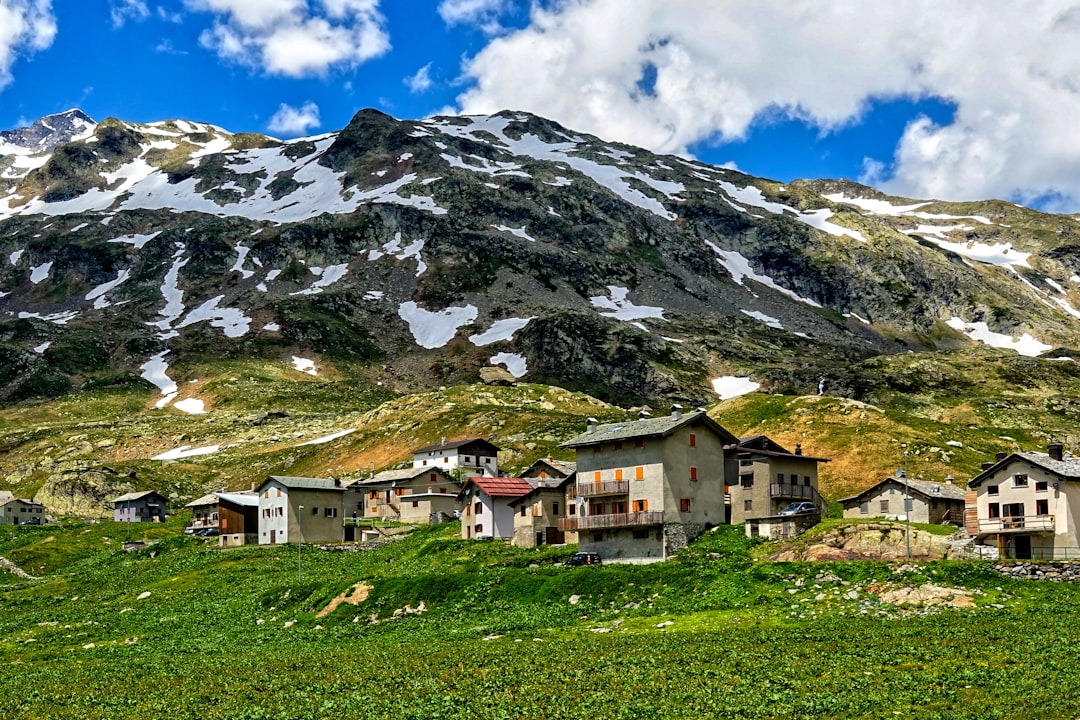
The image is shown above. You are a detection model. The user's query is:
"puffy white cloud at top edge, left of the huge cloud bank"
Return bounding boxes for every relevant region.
[185,0,390,78]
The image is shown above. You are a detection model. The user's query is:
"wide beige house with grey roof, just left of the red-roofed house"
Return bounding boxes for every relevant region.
[350,466,461,525]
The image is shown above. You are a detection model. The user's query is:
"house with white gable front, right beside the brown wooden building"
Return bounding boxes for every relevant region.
[257,475,360,545]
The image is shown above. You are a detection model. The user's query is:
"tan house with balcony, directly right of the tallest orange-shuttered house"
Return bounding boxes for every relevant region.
[728,435,828,525]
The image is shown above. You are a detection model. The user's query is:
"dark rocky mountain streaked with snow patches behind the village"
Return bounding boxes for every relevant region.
[0,110,1080,404]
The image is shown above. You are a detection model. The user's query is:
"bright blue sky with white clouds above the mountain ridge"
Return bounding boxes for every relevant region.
[0,0,1080,212]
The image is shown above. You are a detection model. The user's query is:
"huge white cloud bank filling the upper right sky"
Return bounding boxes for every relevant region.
[453,0,1080,207]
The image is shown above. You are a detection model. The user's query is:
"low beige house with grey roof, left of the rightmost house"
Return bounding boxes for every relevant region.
[840,479,966,526]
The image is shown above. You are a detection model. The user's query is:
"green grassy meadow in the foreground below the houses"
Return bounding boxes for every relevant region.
[0,524,1080,719]
